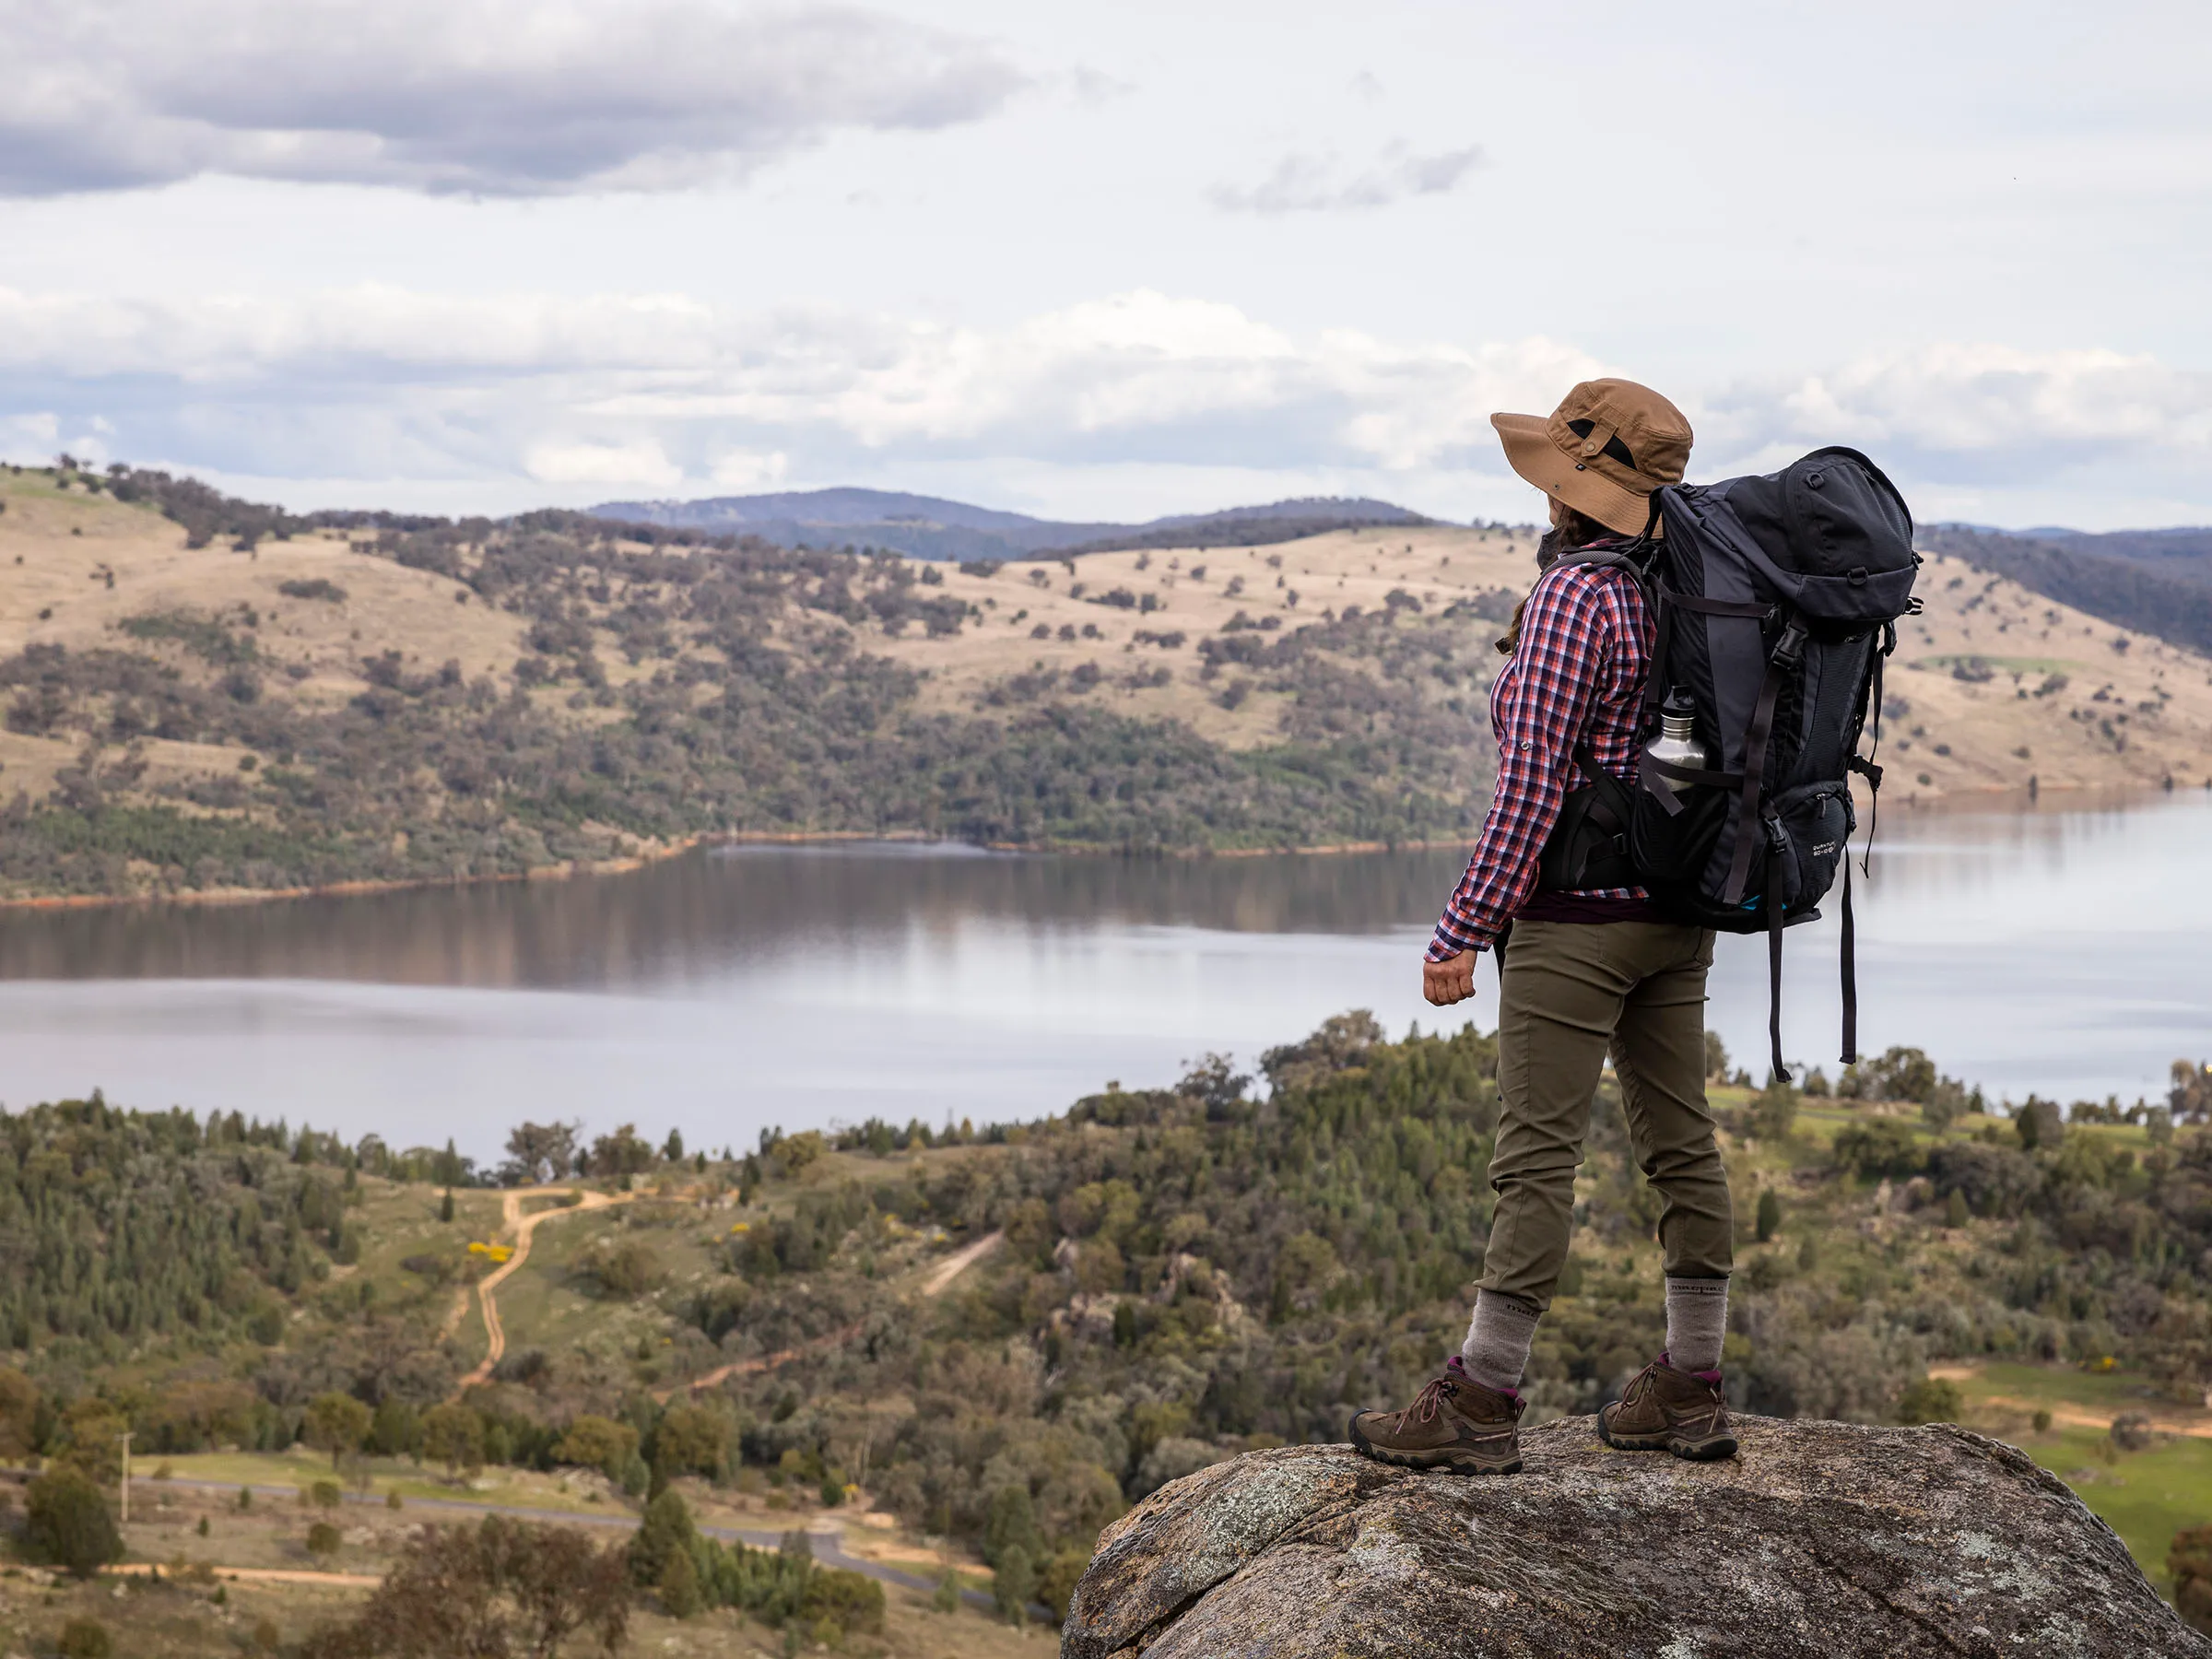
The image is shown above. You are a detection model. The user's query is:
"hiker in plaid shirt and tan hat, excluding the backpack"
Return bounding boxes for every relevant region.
[1351,381,1736,1473]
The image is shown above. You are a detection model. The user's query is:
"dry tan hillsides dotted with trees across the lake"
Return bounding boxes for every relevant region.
[0,469,2212,898]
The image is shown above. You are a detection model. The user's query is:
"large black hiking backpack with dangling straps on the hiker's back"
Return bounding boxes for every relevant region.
[1539,449,1920,1077]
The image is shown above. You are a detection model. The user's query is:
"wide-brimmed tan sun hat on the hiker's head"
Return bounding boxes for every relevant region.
[1491,381,1694,535]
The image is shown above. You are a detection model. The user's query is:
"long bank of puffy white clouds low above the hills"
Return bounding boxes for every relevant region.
[0,288,2212,522]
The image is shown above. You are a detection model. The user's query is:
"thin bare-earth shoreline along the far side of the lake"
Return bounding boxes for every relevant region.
[0,785,2183,916]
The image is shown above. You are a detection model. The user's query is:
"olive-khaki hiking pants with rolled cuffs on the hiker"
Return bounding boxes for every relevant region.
[1477,923,1735,1312]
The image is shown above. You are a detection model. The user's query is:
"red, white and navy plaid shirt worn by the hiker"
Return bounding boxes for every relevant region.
[1429,553,1653,962]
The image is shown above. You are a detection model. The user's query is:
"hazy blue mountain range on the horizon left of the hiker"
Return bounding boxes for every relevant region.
[591,488,1431,559]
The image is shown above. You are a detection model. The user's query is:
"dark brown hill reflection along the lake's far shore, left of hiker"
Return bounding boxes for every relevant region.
[0,842,1465,989]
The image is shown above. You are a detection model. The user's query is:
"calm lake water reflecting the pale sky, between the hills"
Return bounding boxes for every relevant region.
[0,794,2212,1159]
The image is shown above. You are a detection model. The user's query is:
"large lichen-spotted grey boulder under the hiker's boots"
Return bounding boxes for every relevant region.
[1060,1418,2212,1659]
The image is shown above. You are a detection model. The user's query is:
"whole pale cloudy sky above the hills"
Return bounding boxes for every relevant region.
[0,0,2212,526]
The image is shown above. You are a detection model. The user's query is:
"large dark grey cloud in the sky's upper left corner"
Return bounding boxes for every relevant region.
[0,0,1022,194]
